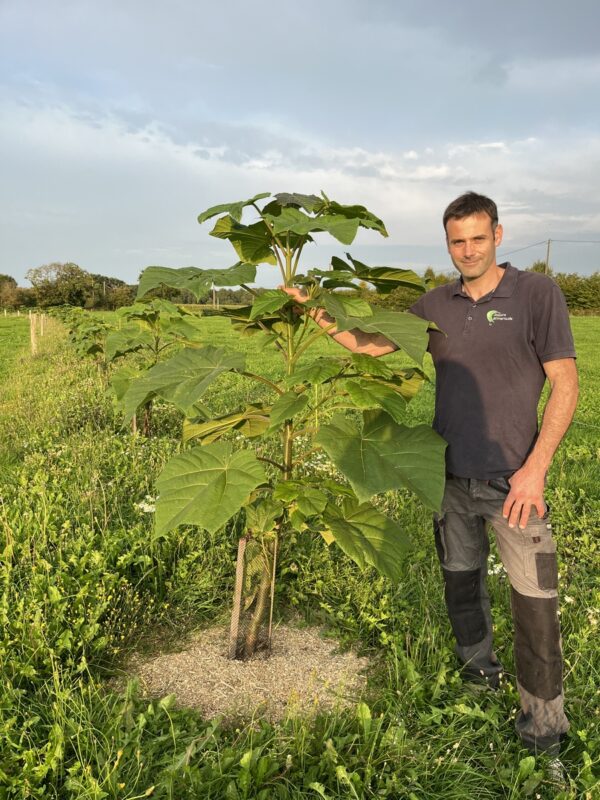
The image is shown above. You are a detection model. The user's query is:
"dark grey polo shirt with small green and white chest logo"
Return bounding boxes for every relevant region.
[410,264,575,478]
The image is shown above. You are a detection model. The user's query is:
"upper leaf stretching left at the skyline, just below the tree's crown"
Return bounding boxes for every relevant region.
[137,261,256,300]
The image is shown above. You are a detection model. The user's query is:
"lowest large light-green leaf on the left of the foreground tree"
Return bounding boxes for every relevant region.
[156,442,266,535]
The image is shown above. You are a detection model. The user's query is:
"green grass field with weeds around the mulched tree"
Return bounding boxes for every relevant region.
[0,317,600,800]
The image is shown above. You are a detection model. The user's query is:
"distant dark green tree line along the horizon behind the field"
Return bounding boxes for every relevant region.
[0,261,600,314]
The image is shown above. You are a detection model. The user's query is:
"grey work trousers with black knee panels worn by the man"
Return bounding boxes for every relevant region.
[434,476,569,753]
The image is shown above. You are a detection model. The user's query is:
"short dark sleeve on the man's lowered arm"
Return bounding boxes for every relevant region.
[533,281,576,364]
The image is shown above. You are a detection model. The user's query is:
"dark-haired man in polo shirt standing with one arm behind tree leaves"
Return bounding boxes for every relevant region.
[287,192,578,754]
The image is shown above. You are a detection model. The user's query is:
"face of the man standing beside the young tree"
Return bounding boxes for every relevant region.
[446,212,502,281]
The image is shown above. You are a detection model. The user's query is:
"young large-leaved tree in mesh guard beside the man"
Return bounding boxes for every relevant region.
[122,193,445,657]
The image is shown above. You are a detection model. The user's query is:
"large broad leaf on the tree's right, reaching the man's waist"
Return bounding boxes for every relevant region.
[315,411,446,511]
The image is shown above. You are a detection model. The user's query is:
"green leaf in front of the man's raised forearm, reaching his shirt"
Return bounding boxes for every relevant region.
[335,308,429,364]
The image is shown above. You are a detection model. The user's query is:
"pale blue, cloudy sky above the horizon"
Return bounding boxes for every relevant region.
[0,0,600,286]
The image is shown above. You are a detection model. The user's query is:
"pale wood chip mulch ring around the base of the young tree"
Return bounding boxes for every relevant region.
[118,625,369,722]
